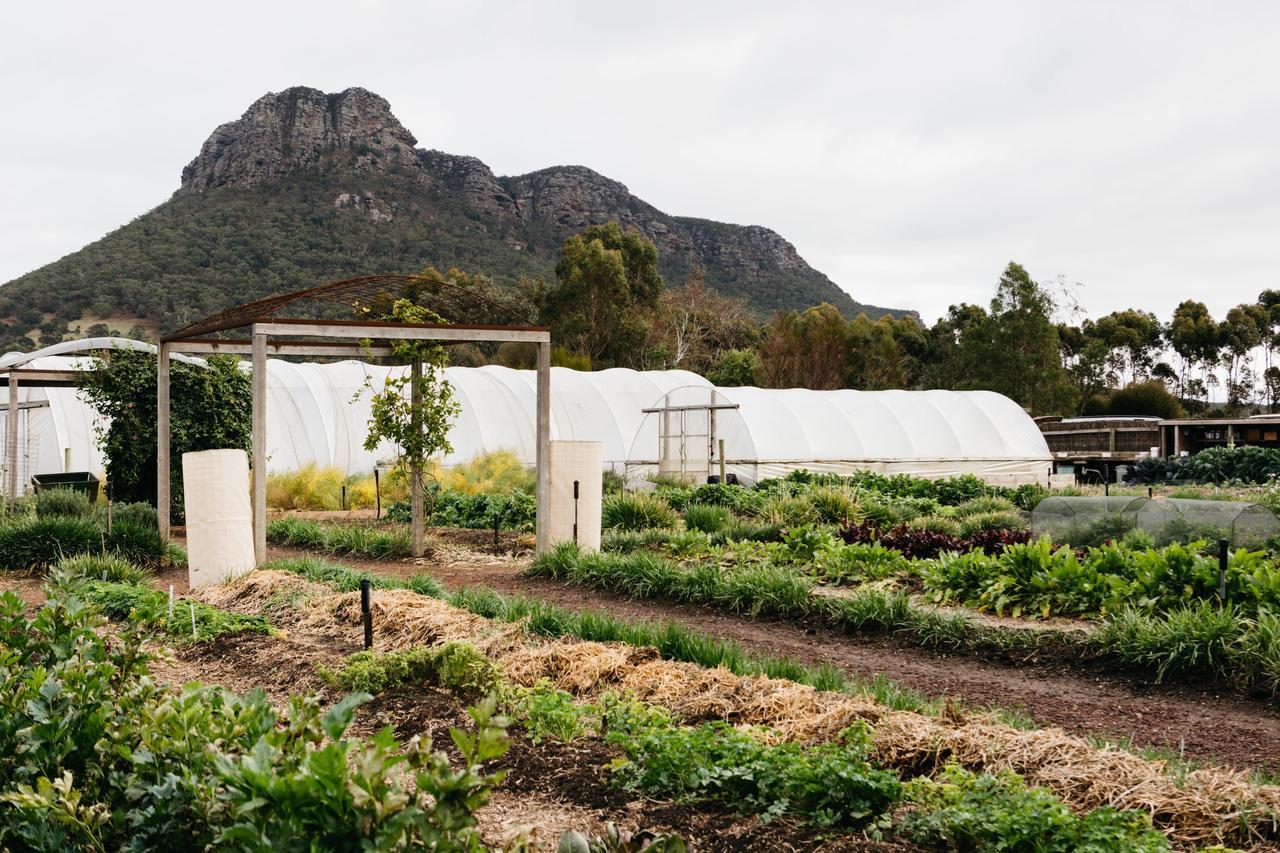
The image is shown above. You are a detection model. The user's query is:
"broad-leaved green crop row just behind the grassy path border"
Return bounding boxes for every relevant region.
[604,515,1280,617]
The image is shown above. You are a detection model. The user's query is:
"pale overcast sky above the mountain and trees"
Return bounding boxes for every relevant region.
[0,0,1280,320]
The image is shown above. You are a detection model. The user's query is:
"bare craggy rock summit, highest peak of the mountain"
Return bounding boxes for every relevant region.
[178,86,420,193]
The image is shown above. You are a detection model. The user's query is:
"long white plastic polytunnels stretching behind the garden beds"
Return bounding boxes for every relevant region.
[0,338,1051,484]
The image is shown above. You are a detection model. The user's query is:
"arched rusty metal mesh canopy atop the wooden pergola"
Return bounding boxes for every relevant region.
[161,275,536,343]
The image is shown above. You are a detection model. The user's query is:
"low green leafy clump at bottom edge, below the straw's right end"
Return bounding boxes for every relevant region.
[901,765,1170,853]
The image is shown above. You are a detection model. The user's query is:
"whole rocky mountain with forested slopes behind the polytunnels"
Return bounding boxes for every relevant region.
[0,88,906,345]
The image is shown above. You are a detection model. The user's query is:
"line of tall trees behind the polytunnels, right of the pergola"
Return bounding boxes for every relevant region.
[527,223,1280,416]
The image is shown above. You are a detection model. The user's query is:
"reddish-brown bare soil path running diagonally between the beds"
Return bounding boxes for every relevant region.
[257,532,1280,774]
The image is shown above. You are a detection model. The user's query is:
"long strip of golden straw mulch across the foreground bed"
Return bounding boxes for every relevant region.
[204,571,1280,850]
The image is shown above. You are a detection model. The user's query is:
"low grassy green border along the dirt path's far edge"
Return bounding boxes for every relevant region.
[527,543,1280,694]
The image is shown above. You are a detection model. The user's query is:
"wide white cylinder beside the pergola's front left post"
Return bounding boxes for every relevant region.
[182,450,253,589]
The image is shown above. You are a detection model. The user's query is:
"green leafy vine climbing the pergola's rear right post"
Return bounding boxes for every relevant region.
[360,298,461,557]
